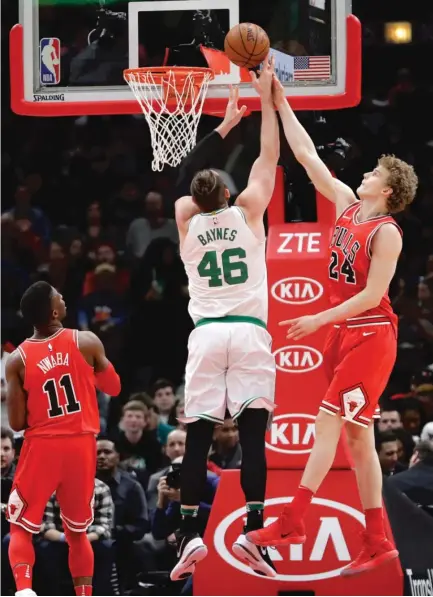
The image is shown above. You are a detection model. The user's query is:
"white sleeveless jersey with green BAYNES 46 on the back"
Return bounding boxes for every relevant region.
[181,206,268,323]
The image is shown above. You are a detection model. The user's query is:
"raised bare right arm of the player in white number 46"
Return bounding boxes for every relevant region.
[236,57,280,220]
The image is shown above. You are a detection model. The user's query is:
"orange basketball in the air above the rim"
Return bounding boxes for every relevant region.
[224,23,270,68]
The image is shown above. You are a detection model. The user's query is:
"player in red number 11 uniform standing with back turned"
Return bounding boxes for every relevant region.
[6,282,120,595]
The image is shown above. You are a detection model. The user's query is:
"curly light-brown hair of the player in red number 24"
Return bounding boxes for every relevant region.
[379,154,418,213]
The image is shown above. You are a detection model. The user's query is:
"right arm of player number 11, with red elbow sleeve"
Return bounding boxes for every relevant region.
[78,332,121,396]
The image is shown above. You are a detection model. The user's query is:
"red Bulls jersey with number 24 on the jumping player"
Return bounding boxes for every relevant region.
[329,201,402,325]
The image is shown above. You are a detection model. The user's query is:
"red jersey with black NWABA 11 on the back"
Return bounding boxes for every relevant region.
[18,328,99,437]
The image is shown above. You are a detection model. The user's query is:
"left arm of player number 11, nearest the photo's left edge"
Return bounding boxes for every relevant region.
[6,350,27,431]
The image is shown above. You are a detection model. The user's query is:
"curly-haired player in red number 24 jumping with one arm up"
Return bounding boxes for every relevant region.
[247,80,418,575]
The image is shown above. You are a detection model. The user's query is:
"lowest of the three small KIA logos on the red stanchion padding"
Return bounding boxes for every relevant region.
[266,413,316,454]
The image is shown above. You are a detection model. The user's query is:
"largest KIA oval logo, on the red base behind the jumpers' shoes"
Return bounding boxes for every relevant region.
[214,497,365,582]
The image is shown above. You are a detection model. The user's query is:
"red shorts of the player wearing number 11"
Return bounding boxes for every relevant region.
[7,434,96,533]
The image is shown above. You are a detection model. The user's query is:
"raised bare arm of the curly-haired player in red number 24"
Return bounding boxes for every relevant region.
[273,77,356,217]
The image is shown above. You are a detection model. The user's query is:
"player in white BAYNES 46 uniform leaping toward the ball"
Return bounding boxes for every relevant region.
[171,60,280,580]
